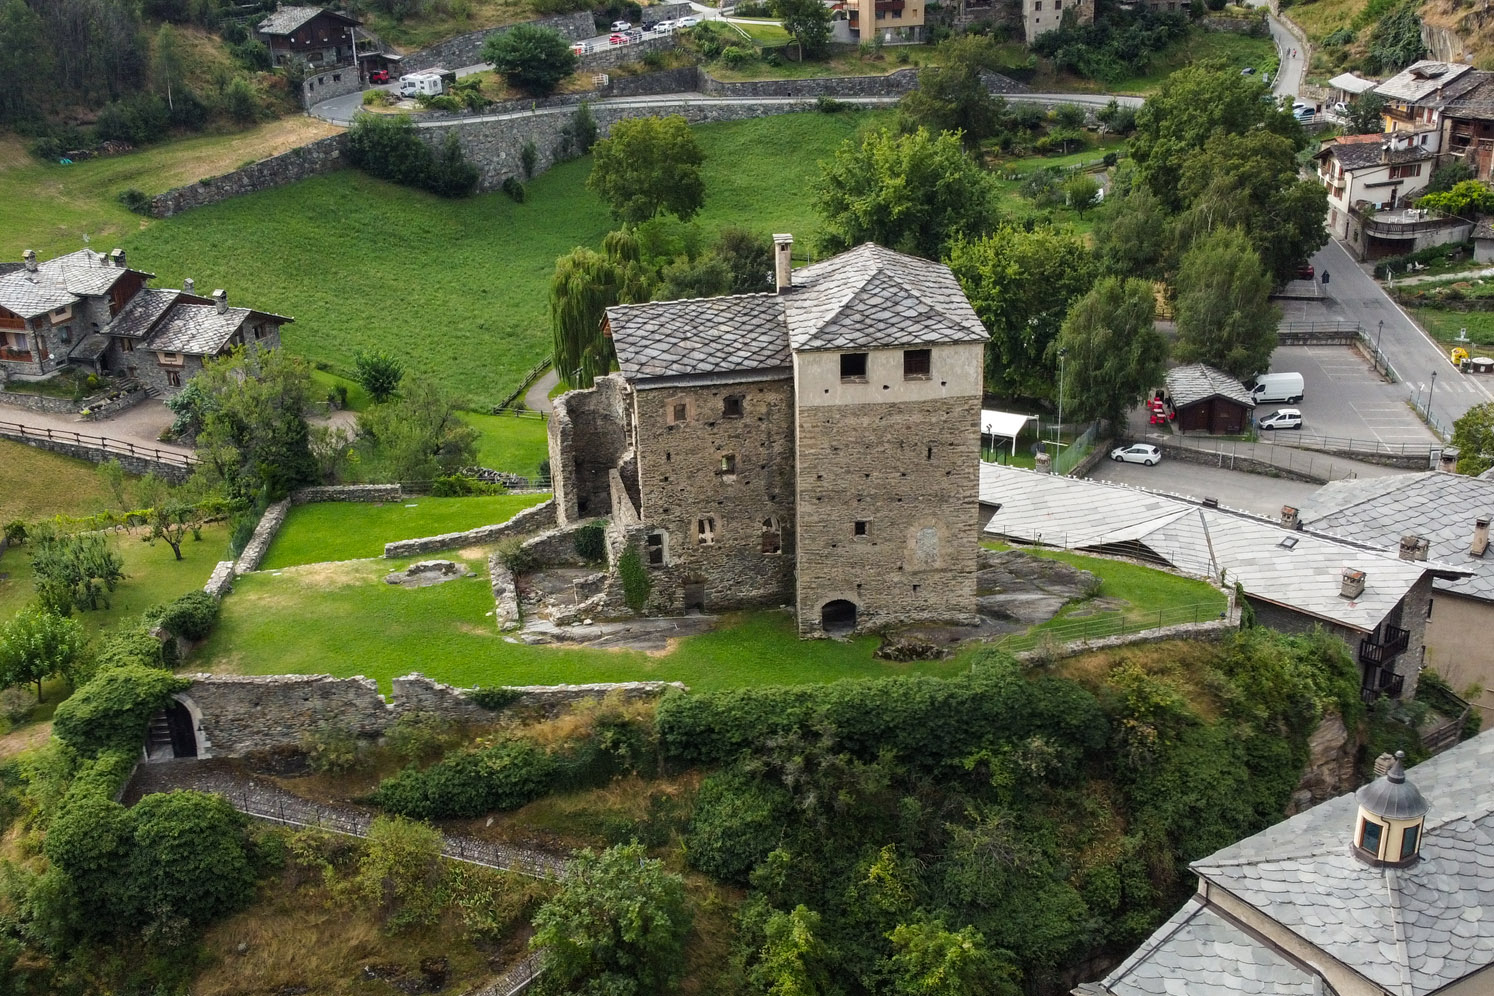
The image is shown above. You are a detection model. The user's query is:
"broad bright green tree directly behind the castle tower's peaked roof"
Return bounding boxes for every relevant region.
[814,128,996,260]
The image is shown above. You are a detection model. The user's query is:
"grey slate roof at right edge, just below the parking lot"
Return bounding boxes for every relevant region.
[1298,470,1494,600]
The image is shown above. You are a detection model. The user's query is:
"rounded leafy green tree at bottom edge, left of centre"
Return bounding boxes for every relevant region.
[530,844,690,996]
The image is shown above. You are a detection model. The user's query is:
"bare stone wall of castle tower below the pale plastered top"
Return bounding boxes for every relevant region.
[798,396,980,633]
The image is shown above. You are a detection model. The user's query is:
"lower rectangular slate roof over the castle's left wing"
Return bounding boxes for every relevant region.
[607,294,789,381]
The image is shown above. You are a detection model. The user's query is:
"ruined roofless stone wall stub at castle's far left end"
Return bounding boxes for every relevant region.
[548,373,632,526]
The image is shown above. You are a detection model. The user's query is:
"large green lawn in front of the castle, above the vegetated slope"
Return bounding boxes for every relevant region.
[191,558,967,690]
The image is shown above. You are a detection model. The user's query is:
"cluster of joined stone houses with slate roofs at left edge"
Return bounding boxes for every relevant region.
[0,249,293,396]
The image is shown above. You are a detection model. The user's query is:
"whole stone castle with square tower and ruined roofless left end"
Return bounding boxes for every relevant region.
[550,236,988,635]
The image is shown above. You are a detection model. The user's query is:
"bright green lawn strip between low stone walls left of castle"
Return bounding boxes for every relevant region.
[260,494,550,572]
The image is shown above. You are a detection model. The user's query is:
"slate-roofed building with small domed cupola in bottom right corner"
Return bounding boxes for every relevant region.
[1073,732,1494,996]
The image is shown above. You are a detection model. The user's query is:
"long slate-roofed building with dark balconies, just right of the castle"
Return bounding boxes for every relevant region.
[980,463,1472,702]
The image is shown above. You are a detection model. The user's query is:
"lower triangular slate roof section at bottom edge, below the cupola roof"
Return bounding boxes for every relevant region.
[1080,897,1322,996]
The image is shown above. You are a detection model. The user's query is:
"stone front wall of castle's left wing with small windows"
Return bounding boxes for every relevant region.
[635,378,795,612]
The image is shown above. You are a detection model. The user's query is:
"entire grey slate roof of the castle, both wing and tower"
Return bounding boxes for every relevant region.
[607,243,989,381]
